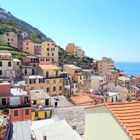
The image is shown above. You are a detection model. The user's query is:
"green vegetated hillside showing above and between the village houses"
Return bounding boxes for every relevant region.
[0,8,93,68]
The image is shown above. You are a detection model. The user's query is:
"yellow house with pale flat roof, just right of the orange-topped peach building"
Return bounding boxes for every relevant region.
[64,65,86,85]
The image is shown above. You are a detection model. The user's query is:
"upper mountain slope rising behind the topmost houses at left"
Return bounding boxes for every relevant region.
[0,8,51,42]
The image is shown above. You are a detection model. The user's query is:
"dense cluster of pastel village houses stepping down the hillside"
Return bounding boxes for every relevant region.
[0,32,140,140]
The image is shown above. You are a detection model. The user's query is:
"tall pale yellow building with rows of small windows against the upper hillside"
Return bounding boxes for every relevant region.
[41,41,58,64]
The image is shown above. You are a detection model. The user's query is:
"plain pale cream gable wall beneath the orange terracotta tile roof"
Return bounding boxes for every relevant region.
[84,106,130,140]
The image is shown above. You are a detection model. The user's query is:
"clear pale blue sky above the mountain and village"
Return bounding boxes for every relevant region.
[0,0,140,62]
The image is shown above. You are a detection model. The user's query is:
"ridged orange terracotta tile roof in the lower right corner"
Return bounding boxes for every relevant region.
[107,102,140,140]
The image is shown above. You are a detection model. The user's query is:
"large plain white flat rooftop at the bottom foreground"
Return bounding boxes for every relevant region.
[32,120,81,140]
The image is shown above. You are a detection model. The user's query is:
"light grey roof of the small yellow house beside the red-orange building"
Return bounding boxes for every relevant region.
[30,89,50,100]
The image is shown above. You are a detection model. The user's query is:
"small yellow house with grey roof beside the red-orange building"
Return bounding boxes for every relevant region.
[30,90,54,121]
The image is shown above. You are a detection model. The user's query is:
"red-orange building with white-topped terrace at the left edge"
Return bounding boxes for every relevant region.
[0,83,31,122]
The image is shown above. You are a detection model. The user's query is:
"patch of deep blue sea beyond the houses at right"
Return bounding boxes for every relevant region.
[115,62,140,75]
